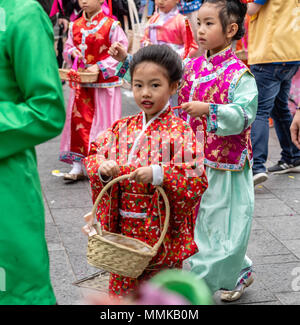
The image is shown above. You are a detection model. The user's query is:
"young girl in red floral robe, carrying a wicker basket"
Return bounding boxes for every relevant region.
[84,45,207,296]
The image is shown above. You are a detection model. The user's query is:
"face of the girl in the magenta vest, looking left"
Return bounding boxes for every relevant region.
[197,3,231,55]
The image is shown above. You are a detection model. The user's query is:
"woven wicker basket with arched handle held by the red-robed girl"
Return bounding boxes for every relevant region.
[87,174,170,278]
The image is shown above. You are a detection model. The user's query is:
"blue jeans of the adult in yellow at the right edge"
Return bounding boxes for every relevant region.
[251,64,300,174]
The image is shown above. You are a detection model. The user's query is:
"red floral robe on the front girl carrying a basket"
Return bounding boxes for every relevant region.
[84,108,207,295]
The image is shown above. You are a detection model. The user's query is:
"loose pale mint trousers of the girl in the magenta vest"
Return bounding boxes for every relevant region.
[188,162,254,292]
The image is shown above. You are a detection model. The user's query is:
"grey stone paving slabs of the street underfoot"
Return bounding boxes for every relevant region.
[37,87,300,305]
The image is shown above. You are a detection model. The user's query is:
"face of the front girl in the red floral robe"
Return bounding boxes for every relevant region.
[132,62,177,122]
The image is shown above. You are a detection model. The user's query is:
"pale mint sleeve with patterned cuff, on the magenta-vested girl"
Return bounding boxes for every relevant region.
[207,72,258,136]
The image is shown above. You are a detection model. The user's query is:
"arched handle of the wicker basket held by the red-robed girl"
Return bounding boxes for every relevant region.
[92,174,170,251]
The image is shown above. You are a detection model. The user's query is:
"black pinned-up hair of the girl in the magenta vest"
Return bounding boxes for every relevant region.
[203,0,247,41]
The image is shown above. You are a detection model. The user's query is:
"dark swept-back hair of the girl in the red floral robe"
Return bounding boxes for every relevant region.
[130,45,183,84]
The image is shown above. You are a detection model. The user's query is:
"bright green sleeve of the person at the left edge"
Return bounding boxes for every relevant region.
[0,1,65,160]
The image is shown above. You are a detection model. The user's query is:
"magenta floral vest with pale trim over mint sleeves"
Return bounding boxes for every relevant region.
[178,48,253,171]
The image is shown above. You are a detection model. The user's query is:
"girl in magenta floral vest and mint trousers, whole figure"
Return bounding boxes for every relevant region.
[179,0,258,301]
